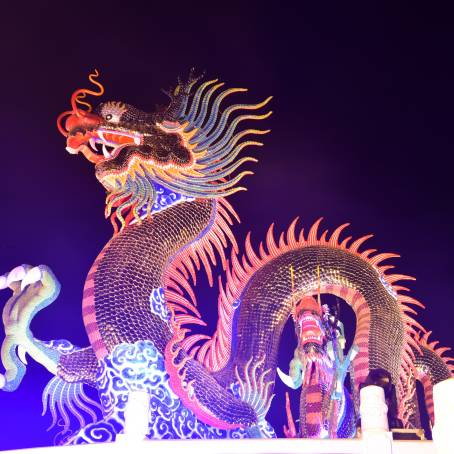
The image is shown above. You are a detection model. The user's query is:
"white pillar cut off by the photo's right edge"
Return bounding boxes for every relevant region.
[432,377,454,454]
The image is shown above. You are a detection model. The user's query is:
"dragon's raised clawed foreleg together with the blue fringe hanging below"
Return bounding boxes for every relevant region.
[0,265,102,443]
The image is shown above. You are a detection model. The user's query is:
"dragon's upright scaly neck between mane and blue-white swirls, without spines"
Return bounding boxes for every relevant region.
[83,193,220,359]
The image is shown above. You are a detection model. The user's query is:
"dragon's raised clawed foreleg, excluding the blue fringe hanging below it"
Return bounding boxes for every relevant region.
[0,265,97,391]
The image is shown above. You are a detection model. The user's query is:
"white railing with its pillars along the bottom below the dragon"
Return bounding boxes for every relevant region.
[3,378,454,454]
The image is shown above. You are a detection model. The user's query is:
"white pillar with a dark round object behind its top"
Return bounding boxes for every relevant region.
[359,385,392,454]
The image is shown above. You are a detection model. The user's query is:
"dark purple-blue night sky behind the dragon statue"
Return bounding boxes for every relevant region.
[0,2,454,449]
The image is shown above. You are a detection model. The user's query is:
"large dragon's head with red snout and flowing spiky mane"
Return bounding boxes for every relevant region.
[57,70,271,230]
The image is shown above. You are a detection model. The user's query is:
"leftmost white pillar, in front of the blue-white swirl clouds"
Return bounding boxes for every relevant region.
[117,391,150,443]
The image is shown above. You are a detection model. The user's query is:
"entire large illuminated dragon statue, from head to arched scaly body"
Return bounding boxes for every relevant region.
[0,74,451,443]
